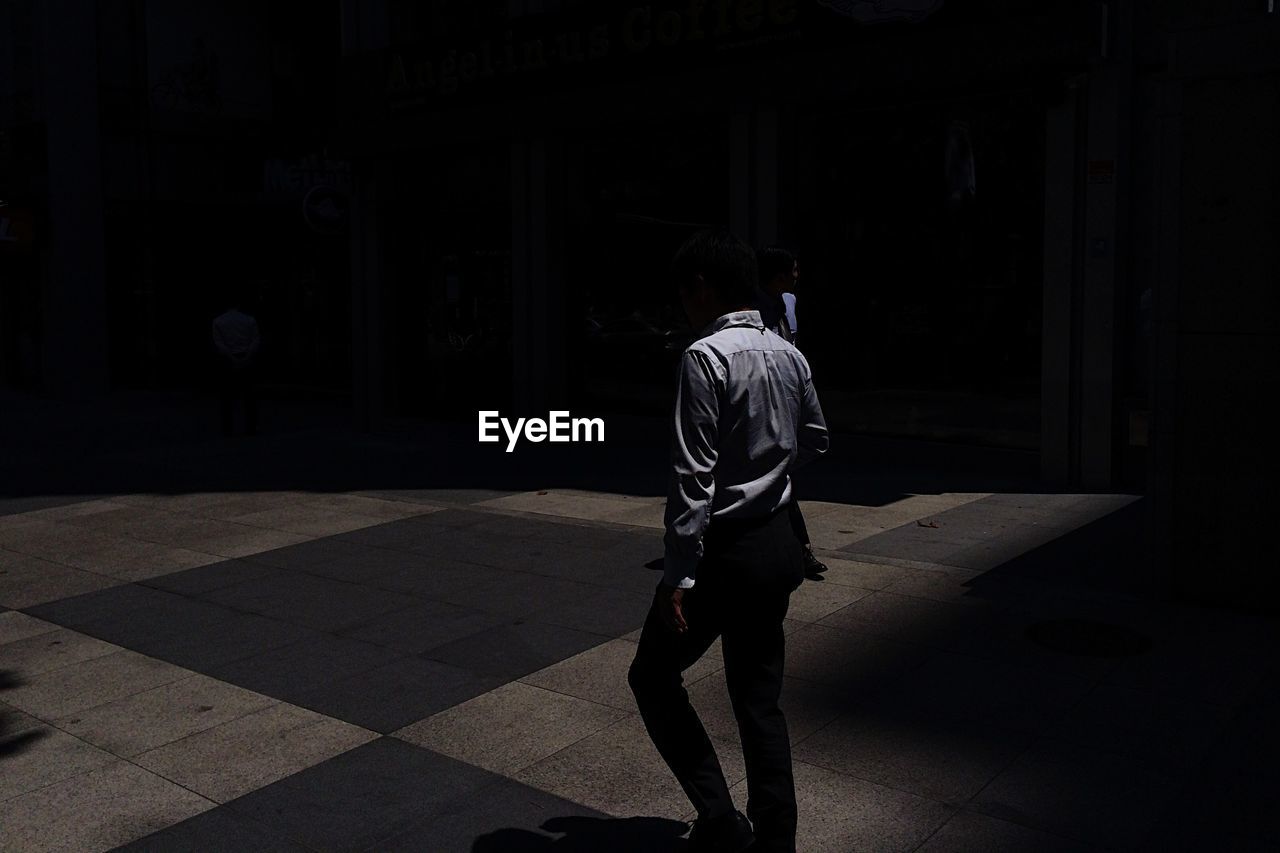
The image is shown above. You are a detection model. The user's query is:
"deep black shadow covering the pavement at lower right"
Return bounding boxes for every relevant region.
[783,496,1280,852]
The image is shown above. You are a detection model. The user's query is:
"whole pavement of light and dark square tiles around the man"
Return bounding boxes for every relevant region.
[0,481,1280,853]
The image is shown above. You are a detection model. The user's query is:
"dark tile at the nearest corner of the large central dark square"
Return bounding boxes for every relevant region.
[292,657,503,734]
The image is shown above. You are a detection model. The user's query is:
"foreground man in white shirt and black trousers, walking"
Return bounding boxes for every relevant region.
[628,231,828,853]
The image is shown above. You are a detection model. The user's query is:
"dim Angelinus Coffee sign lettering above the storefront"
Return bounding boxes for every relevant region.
[387,0,799,96]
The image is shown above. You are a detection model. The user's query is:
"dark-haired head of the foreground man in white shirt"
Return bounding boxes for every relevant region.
[671,228,756,329]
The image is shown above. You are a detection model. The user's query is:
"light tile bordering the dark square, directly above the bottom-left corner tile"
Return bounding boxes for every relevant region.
[55,675,276,758]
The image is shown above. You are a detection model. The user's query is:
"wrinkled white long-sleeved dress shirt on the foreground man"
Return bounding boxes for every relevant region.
[663,311,828,589]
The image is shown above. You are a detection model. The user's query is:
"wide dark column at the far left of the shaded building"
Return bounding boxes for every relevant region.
[41,0,110,397]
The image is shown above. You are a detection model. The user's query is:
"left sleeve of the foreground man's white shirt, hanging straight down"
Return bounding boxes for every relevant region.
[663,350,722,589]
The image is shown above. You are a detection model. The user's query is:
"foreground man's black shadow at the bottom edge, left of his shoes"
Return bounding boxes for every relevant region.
[471,817,689,853]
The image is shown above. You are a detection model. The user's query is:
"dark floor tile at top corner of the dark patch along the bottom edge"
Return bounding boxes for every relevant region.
[229,738,500,850]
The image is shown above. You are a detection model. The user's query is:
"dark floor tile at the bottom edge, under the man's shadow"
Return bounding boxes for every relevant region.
[370,780,689,853]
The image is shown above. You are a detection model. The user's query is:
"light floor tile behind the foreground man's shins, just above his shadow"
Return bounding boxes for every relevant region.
[515,715,746,820]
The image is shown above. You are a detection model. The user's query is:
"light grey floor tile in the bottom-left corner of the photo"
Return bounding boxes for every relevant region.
[0,761,214,853]
